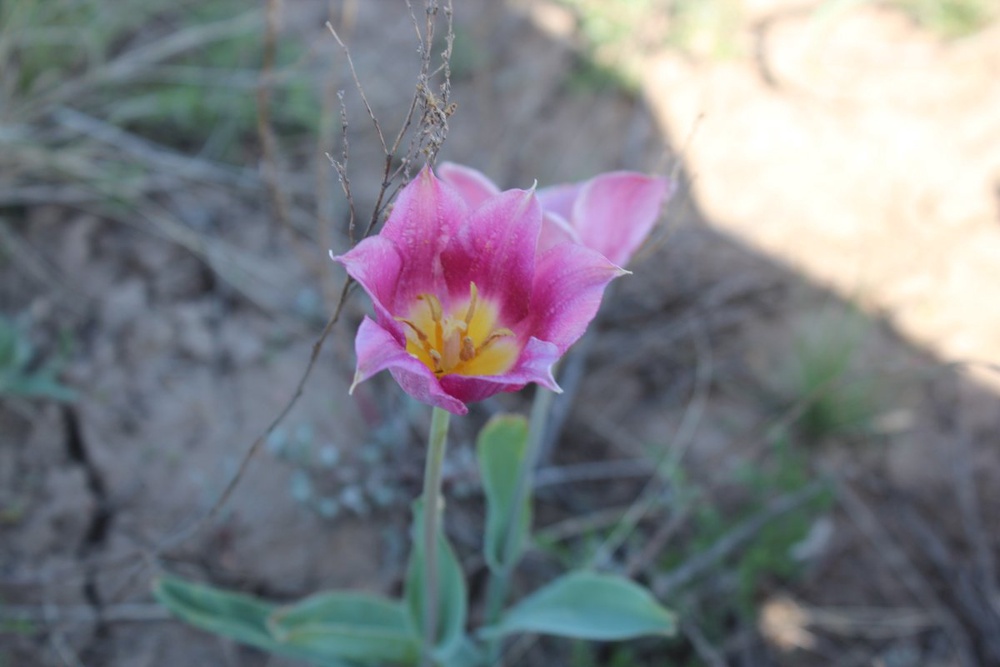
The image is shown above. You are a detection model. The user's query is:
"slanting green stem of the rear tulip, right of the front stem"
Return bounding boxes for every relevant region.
[486,387,555,665]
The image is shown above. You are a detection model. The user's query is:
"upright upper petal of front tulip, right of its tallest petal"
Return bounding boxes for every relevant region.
[441,190,542,324]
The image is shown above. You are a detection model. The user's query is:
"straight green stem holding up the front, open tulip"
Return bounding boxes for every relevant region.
[423,407,451,667]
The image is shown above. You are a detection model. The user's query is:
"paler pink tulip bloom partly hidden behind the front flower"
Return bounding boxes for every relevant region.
[438,162,672,266]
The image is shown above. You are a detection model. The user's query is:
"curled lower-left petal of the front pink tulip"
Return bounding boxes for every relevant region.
[351,317,469,415]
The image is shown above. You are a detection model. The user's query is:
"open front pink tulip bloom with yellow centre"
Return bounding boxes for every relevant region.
[333,168,626,414]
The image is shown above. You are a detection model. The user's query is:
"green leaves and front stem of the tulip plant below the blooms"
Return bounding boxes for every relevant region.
[154,408,674,667]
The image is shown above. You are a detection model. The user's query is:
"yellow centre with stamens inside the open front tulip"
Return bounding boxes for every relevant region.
[396,283,518,377]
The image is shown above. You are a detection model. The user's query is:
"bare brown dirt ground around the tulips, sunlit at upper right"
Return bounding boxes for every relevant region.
[0,0,1000,667]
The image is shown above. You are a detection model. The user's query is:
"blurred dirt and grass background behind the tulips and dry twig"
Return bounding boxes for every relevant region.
[0,0,1000,667]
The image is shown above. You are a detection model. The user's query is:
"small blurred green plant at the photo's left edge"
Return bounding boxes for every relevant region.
[0,316,76,401]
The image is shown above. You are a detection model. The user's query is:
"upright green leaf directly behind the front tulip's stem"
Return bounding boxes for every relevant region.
[405,500,467,662]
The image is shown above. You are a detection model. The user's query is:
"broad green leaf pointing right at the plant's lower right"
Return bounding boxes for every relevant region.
[480,572,675,641]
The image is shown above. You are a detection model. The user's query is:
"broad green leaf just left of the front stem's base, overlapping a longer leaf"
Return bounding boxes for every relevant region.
[268,592,420,664]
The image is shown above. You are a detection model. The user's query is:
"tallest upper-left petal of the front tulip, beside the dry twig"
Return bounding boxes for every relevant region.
[379,167,469,312]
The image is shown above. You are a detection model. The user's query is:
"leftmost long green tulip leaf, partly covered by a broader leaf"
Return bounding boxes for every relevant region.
[153,577,354,667]
